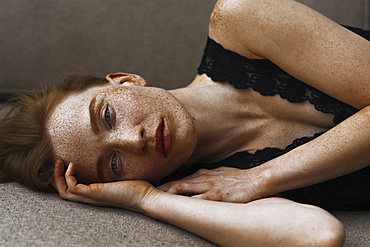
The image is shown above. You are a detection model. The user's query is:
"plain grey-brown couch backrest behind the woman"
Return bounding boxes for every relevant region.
[0,0,370,98]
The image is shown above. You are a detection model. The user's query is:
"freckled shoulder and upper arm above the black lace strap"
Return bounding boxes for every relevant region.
[209,0,370,109]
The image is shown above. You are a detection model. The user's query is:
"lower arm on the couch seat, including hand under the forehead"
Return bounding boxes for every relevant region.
[54,161,344,246]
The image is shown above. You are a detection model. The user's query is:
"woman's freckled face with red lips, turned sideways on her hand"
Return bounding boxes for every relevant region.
[47,79,197,183]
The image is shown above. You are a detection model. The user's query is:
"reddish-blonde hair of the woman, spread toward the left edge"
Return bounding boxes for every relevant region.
[0,76,108,191]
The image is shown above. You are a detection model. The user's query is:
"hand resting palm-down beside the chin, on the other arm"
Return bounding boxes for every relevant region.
[157,167,267,202]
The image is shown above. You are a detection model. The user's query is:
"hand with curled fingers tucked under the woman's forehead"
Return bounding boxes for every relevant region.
[52,160,159,212]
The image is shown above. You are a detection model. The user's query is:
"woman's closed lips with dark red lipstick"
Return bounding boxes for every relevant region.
[155,118,172,158]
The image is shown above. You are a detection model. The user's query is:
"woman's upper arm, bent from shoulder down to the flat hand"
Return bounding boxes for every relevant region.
[160,0,370,202]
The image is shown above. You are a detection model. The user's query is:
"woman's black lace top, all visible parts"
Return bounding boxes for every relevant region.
[161,27,370,209]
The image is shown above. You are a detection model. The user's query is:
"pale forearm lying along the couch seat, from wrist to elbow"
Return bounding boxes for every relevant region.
[143,192,343,246]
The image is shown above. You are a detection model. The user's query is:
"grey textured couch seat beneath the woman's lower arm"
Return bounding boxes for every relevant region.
[0,183,370,247]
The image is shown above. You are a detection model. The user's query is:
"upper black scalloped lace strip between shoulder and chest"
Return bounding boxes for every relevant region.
[198,38,357,124]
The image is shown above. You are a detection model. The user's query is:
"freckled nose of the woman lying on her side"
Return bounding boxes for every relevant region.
[111,126,146,155]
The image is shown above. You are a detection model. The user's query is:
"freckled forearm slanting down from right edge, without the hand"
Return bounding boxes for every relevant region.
[256,107,370,194]
